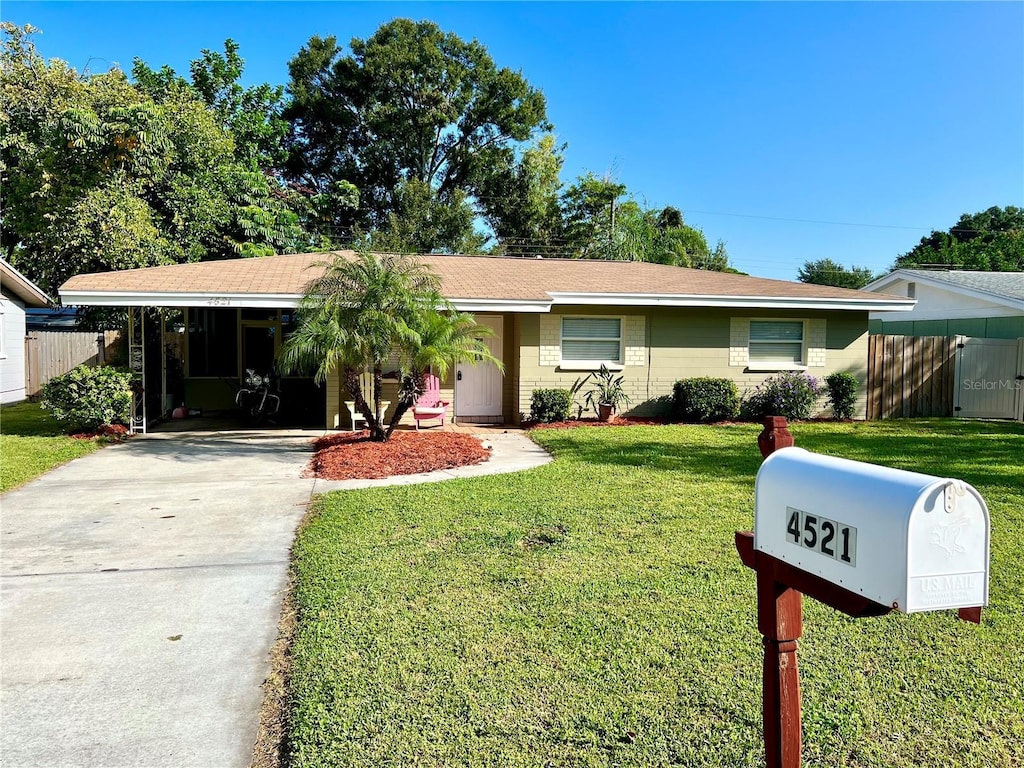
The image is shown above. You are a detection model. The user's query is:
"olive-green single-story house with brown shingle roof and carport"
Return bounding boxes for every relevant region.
[60,252,914,428]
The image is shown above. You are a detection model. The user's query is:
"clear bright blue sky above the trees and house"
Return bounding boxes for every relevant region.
[2,0,1024,280]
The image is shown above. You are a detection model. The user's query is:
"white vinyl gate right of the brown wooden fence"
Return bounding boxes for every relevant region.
[953,336,1024,421]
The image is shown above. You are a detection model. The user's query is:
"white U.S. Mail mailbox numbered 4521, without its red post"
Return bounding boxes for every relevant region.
[754,447,988,613]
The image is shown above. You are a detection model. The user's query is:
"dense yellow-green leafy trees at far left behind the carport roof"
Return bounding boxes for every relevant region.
[0,23,311,293]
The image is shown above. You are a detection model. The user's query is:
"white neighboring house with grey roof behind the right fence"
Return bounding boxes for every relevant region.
[862,269,1024,339]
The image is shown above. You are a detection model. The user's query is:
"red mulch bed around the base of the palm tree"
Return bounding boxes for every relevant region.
[309,431,490,480]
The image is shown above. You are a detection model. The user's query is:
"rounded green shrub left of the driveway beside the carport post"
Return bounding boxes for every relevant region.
[40,365,131,432]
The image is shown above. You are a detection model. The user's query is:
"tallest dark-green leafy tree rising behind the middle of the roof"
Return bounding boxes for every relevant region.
[285,18,549,251]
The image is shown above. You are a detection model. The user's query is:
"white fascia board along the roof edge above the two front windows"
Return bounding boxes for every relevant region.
[551,291,918,312]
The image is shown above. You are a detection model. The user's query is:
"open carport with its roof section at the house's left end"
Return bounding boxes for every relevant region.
[60,259,328,432]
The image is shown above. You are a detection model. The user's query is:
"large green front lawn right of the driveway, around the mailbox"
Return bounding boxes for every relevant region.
[289,421,1024,767]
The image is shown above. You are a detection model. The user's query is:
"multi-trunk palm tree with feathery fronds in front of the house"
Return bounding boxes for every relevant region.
[279,252,501,441]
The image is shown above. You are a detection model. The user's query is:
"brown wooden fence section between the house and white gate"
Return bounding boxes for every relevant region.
[867,335,956,419]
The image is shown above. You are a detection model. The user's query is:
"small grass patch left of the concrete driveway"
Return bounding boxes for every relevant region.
[0,402,98,494]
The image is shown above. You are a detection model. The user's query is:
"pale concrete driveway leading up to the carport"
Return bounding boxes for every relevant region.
[0,431,319,768]
